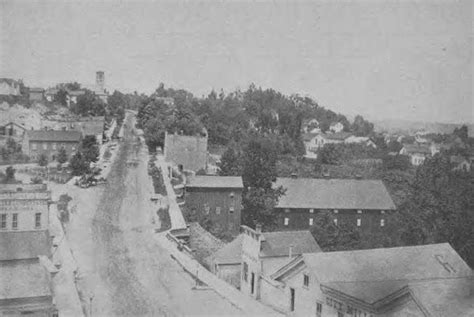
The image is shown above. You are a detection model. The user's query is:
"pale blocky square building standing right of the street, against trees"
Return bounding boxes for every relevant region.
[164,132,207,172]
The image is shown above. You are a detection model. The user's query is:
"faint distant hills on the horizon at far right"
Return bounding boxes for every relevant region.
[372,119,474,137]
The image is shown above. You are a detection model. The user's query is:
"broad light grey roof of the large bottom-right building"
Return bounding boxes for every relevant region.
[272,243,472,304]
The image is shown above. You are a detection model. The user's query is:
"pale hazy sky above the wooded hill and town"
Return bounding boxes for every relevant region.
[0,0,474,123]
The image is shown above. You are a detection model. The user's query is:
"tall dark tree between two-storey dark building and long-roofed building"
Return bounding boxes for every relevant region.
[242,138,284,229]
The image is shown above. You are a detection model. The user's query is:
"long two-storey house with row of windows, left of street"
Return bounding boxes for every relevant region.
[22,130,82,161]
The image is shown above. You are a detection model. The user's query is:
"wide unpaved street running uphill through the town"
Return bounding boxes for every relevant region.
[68,115,243,316]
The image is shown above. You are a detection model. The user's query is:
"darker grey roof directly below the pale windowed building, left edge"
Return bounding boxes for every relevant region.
[0,230,51,260]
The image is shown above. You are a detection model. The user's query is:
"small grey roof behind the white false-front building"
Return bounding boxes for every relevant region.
[261,230,321,256]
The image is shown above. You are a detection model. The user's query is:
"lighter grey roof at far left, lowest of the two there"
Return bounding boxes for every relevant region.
[0,261,52,300]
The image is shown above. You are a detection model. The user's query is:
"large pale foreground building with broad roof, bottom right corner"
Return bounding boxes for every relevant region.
[261,243,474,317]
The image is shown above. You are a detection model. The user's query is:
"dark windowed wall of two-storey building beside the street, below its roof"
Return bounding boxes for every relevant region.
[185,187,242,234]
